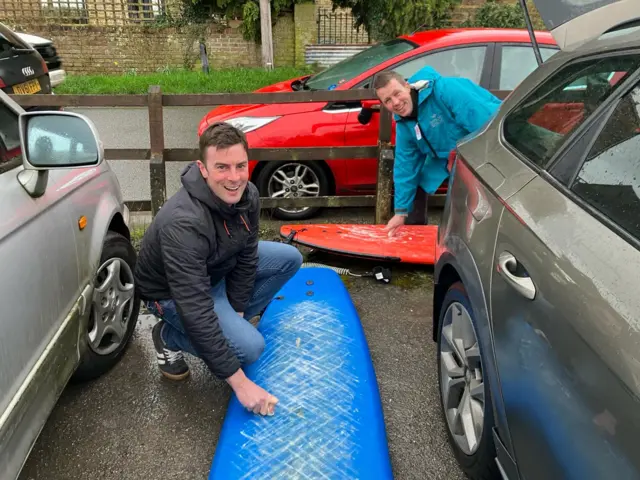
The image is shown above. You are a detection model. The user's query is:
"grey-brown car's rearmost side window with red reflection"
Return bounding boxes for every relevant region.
[503,54,640,167]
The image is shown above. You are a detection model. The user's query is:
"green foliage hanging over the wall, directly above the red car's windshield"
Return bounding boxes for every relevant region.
[333,0,460,41]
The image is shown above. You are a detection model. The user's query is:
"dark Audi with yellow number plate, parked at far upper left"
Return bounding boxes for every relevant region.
[0,23,51,99]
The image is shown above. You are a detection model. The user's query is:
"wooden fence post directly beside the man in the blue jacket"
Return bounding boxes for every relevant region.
[376,106,394,225]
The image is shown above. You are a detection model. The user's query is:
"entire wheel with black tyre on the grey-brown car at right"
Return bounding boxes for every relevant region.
[437,282,501,480]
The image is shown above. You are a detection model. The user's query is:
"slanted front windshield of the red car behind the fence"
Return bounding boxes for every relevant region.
[304,39,417,90]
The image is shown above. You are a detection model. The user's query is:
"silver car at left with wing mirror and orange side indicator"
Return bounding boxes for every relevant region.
[0,92,140,479]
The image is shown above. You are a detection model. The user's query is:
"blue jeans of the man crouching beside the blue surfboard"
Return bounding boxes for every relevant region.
[145,241,302,365]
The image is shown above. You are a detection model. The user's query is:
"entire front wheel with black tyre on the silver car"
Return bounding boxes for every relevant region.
[72,231,140,382]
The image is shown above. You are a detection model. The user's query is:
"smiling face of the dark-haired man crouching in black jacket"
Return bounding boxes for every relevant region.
[198,144,249,205]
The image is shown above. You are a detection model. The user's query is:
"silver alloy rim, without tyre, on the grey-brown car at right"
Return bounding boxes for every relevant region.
[439,302,485,455]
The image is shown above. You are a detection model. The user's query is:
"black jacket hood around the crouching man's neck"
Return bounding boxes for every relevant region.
[180,162,258,219]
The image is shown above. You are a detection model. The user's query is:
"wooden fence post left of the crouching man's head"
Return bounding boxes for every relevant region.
[148,85,167,217]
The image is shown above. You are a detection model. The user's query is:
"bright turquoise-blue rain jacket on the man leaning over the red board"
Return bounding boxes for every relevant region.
[393,67,501,214]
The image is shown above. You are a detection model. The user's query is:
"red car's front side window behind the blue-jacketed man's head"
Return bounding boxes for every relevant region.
[393,45,487,85]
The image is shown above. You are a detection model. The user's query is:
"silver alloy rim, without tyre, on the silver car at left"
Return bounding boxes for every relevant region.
[89,257,135,355]
